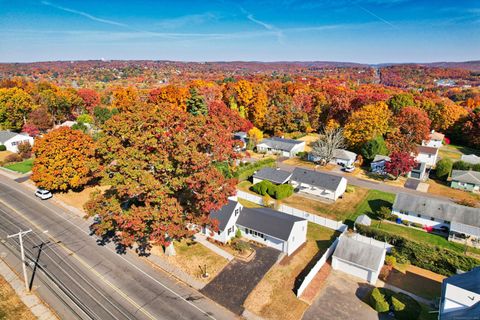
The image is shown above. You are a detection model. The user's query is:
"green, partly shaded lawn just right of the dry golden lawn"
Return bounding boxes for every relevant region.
[345,190,395,227]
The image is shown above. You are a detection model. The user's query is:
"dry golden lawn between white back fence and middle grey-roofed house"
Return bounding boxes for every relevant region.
[281,187,369,221]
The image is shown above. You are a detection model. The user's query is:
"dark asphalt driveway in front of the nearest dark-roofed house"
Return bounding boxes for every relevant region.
[201,246,280,314]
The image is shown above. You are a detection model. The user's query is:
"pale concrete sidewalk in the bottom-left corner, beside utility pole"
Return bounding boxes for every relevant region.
[0,260,57,320]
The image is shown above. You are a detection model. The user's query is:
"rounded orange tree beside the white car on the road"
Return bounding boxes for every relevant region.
[31,127,96,191]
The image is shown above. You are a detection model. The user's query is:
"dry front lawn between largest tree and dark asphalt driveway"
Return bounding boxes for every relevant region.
[151,240,228,282]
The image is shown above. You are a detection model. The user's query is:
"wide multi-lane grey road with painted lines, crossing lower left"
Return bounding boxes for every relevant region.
[0,176,235,320]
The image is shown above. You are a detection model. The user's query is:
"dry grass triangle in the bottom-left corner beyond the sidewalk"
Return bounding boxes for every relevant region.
[0,277,36,320]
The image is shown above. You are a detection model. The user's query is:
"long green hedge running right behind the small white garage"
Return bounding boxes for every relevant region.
[356,224,480,277]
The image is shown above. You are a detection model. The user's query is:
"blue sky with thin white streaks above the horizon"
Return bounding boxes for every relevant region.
[0,0,480,63]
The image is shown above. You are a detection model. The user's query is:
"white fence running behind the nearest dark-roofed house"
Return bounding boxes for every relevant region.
[237,190,348,232]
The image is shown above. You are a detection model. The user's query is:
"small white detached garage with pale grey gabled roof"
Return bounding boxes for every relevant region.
[332,234,387,284]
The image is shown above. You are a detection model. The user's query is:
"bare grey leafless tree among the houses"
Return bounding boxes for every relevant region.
[311,129,345,164]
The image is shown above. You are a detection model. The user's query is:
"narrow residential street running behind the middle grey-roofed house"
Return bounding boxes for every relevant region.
[277,162,452,201]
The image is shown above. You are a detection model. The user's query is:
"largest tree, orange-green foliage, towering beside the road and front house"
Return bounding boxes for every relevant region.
[85,105,235,252]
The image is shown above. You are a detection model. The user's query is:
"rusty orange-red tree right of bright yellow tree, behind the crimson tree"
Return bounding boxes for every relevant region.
[387,107,431,152]
